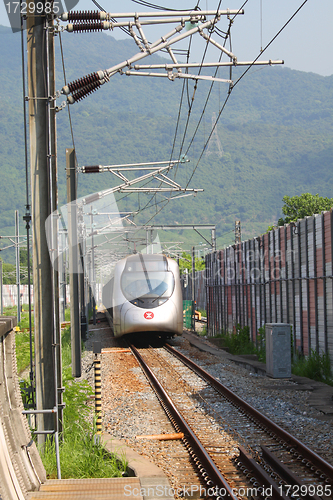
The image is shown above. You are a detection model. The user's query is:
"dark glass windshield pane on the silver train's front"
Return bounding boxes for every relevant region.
[121,269,175,308]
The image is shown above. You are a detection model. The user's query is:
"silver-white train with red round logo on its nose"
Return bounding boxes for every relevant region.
[103,253,183,337]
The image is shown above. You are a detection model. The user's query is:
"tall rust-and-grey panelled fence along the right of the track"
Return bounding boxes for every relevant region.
[205,211,333,361]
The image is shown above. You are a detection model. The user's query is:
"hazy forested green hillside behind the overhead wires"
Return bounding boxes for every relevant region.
[0,23,333,260]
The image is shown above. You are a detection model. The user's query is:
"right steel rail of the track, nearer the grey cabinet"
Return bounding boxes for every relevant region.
[165,344,333,480]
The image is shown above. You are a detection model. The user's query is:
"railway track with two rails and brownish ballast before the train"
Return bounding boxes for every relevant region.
[125,345,333,499]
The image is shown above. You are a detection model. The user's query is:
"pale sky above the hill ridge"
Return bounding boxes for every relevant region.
[0,0,333,76]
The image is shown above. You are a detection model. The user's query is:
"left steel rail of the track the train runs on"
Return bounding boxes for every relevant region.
[129,344,238,500]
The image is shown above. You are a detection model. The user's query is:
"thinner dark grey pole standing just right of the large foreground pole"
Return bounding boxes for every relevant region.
[66,148,81,377]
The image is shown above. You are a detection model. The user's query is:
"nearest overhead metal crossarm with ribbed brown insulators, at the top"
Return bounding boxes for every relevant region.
[57,9,254,104]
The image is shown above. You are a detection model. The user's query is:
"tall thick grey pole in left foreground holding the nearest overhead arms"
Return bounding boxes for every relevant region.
[27,6,61,445]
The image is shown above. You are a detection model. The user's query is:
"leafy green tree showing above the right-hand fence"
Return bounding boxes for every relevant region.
[278,193,333,226]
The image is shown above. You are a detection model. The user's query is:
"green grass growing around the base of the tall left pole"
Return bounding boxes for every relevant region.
[4,306,127,479]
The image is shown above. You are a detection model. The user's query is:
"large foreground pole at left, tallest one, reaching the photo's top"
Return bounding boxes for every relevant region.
[27,9,57,445]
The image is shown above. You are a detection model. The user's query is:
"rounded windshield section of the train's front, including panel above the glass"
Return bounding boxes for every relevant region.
[121,254,175,307]
